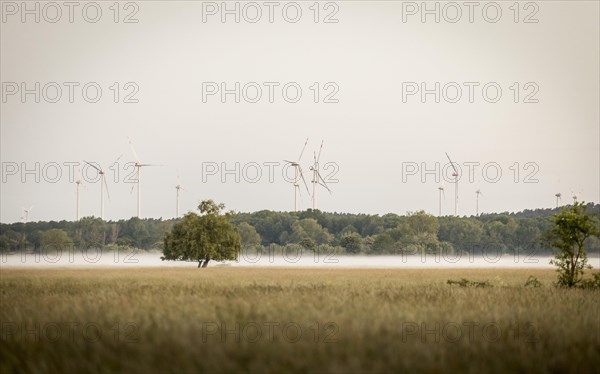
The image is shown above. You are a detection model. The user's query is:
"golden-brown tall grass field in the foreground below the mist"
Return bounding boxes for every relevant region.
[0,268,600,373]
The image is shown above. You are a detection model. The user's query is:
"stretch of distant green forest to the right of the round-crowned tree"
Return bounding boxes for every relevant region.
[234,203,600,254]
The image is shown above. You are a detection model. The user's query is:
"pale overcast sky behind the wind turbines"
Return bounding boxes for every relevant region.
[0,1,600,223]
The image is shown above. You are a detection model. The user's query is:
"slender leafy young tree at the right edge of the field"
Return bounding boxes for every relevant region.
[546,202,600,287]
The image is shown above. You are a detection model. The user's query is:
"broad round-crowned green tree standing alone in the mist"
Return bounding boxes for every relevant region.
[161,200,241,267]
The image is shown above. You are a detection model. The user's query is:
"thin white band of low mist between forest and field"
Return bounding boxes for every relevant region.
[0,251,572,269]
